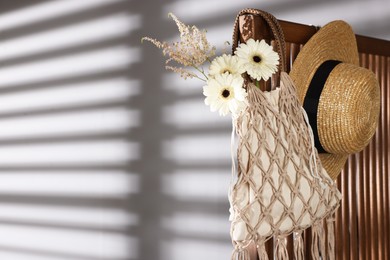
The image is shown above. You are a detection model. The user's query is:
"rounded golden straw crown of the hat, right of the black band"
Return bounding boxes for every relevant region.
[317,63,380,154]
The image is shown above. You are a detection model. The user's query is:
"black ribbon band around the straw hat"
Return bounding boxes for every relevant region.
[303,60,341,153]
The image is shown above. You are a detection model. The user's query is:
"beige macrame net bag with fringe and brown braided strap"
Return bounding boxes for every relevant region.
[229,9,341,260]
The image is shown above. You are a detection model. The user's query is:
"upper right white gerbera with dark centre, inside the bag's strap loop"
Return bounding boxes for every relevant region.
[235,39,279,81]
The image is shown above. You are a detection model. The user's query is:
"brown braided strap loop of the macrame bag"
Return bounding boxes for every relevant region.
[232,8,287,72]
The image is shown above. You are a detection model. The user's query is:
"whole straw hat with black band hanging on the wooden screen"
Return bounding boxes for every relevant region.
[290,21,380,179]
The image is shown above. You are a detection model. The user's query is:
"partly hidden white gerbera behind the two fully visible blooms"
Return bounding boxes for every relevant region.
[209,54,245,76]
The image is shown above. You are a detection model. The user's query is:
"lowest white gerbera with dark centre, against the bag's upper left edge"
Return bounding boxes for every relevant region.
[203,73,247,117]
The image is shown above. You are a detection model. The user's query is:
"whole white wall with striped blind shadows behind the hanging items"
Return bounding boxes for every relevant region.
[0,0,390,260]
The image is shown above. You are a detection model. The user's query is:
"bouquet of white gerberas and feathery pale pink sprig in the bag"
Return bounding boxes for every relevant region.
[142,13,279,118]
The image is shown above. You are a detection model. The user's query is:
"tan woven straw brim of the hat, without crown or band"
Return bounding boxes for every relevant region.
[289,21,359,179]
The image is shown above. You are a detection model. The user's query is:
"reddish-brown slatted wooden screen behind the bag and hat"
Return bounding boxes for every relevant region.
[241,14,390,260]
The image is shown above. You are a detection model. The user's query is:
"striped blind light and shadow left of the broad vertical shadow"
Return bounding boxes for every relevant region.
[0,0,141,260]
